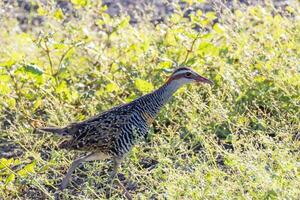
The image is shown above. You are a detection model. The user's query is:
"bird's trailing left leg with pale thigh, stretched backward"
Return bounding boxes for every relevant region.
[59,152,108,190]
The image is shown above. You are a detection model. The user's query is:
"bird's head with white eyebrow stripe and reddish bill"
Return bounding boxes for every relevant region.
[167,67,213,85]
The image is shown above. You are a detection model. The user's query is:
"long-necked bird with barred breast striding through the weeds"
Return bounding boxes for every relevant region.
[40,67,213,190]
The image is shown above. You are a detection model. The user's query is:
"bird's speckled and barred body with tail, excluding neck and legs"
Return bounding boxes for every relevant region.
[42,86,168,156]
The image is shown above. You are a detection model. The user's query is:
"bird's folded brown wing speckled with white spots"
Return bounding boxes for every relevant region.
[60,105,131,151]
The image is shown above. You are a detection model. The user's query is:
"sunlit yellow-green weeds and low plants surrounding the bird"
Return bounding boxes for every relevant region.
[0,0,300,199]
